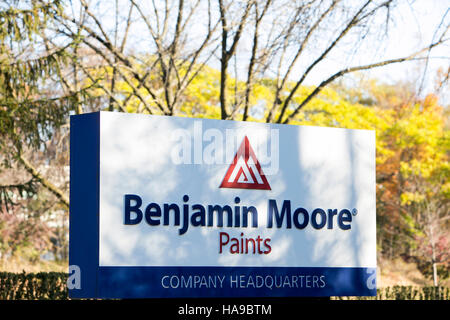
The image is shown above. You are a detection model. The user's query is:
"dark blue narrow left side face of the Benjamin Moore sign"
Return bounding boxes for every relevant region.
[69,112,100,298]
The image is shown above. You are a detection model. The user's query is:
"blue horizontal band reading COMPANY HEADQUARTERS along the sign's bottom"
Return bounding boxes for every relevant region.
[98,266,376,298]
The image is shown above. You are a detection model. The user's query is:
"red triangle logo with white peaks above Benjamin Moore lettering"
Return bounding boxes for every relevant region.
[220,136,271,190]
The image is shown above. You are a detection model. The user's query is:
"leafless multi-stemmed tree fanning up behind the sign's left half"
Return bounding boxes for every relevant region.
[48,0,223,115]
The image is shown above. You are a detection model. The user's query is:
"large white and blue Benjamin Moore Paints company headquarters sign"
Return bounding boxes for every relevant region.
[68,112,376,298]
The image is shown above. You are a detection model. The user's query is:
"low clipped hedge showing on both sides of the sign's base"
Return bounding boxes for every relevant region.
[0,272,450,300]
